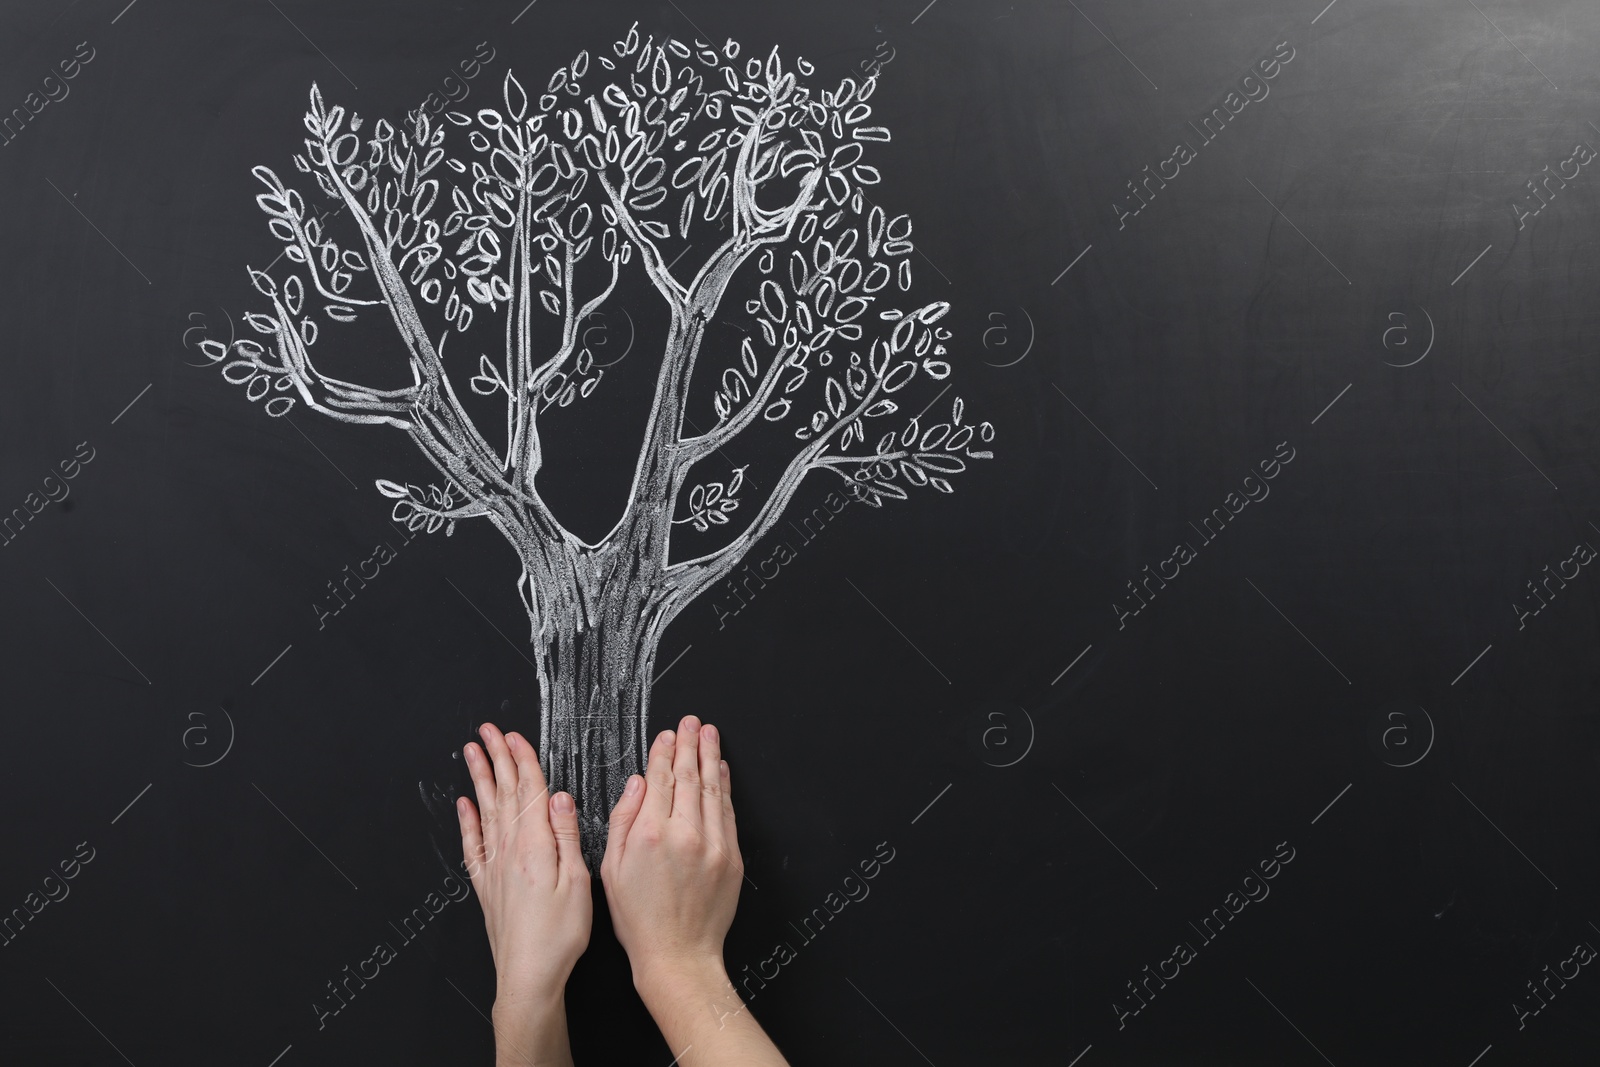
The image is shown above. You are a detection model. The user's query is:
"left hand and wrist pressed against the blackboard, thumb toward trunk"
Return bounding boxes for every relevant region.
[456,723,594,1067]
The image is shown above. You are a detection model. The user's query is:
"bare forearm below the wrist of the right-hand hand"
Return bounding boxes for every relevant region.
[634,960,789,1067]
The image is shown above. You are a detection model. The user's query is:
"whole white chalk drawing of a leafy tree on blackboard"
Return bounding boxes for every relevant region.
[205,24,994,861]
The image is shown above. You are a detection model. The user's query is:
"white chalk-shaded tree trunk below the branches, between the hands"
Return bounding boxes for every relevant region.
[534,589,661,873]
